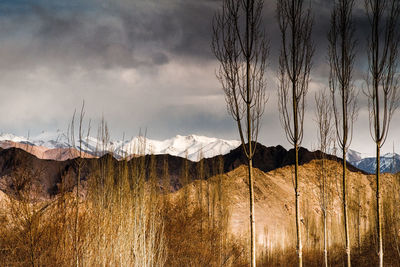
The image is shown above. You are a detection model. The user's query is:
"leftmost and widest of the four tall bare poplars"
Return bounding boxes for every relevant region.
[212,0,269,266]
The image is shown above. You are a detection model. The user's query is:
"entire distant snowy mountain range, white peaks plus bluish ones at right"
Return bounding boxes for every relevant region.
[0,131,400,173]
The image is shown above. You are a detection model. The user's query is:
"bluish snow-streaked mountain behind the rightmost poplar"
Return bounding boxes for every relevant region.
[348,153,400,173]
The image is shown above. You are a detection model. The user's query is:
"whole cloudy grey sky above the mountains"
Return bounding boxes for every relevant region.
[0,0,400,155]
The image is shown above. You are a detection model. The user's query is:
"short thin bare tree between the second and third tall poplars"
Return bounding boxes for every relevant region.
[315,92,332,267]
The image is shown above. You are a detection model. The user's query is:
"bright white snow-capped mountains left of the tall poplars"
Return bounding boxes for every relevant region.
[0,131,240,161]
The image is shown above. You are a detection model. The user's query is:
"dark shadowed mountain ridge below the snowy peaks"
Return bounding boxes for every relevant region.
[0,144,366,200]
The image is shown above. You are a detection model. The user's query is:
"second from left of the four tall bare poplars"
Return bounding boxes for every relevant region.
[277,0,314,266]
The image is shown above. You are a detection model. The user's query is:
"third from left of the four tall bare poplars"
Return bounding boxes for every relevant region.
[328,0,357,266]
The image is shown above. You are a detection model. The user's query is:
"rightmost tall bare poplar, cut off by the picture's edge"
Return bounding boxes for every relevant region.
[365,0,400,266]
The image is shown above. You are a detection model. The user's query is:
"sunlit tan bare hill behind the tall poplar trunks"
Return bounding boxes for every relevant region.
[171,160,395,254]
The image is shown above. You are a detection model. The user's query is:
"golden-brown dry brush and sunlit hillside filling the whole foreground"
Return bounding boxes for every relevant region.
[0,161,400,266]
